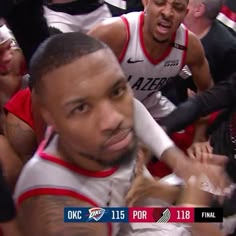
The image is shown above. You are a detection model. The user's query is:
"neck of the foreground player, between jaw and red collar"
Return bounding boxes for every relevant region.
[45,134,107,171]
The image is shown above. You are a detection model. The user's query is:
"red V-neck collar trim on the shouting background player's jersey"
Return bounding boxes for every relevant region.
[139,12,176,65]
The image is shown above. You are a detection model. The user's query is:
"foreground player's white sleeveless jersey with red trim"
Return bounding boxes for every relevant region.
[14,136,189,236]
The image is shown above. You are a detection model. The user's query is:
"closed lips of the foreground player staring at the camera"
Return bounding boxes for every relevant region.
[104,129,133,151]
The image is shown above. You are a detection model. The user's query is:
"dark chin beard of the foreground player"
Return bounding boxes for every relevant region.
[79,139,138,167]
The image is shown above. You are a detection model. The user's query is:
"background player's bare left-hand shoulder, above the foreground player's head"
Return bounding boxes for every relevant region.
[88,17,127,57]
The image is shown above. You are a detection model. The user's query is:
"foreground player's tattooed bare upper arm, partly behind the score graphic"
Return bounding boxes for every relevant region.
[18,195,108,236]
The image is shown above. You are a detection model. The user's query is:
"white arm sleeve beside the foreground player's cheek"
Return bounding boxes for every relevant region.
[134,99,174,158]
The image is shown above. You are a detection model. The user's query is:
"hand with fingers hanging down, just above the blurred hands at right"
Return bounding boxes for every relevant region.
[187,141,213,161]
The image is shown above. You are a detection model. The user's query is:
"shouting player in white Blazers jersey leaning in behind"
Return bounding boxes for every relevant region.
[89,0,213,120]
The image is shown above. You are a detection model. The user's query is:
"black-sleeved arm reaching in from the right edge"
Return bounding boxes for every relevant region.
[160,74,236,133]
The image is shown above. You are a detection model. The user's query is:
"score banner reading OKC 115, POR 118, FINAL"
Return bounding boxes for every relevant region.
[64,207,223,223]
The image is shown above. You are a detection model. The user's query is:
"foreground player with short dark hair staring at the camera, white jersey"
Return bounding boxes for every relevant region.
[15,33,229,236]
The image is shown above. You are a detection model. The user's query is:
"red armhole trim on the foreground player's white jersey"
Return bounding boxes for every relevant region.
[17,188,112,236]
